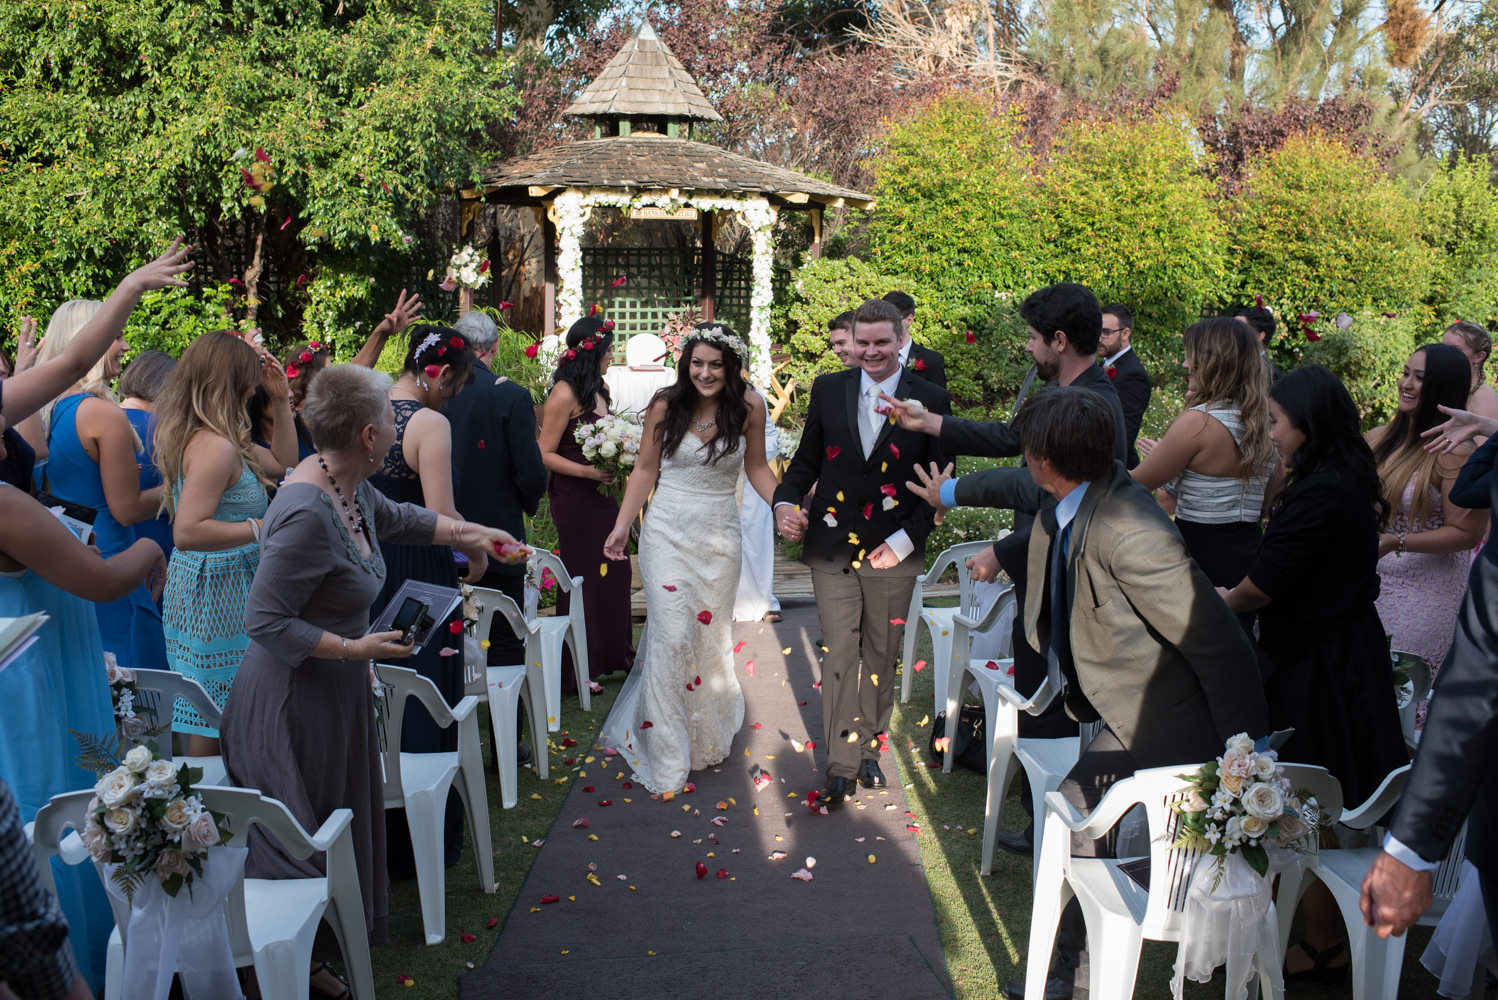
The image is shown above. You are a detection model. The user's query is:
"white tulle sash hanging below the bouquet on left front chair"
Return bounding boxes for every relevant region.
[103,844,249,1000]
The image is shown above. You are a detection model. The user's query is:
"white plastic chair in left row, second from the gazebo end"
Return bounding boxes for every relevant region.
[463,587,550,808]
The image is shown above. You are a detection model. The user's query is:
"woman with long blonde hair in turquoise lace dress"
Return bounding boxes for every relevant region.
[156,332,297,756]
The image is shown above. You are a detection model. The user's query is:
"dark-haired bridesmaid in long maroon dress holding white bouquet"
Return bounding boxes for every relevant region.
[541,316,635,689]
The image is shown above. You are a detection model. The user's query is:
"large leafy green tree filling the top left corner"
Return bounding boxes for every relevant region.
[0,0,514,347]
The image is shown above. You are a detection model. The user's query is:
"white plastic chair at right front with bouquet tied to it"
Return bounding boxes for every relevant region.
[1025,765,1284,1000]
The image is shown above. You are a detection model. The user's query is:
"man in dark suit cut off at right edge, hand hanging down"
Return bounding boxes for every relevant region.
[1362,413,1498,937]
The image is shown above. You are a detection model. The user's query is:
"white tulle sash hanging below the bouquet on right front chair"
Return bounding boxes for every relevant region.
[1170,849,1296,1000]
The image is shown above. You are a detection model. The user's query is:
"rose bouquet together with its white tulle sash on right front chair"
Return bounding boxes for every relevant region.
[1170,734,1318,1000]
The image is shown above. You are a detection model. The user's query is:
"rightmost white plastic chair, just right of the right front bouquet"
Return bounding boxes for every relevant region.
[1279,763,1467,1000]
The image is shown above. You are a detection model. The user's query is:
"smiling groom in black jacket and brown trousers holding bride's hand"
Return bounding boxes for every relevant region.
[774,299,951,805]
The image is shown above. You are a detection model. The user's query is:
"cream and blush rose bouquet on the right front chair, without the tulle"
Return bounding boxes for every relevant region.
[1171,732,1317,879]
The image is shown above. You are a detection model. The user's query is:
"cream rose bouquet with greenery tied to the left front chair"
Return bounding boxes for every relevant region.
[79,746,229,901]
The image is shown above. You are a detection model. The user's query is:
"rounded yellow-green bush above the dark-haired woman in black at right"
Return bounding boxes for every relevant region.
[1227,135,1434,324]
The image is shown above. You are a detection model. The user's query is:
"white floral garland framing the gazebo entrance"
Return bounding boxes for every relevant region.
[553,187,777,386]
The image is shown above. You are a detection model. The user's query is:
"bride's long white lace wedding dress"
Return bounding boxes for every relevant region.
[598,433,745,792]
